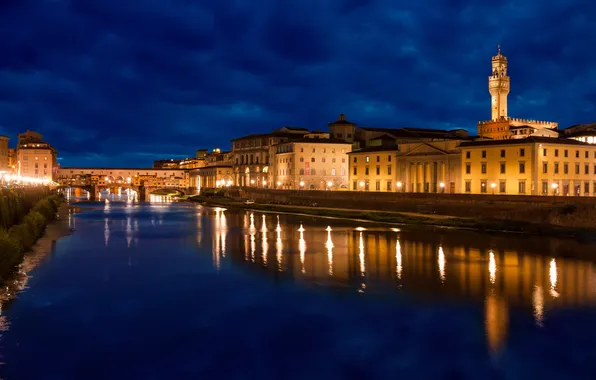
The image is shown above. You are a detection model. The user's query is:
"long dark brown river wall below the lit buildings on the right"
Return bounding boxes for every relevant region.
[225,188,596,229]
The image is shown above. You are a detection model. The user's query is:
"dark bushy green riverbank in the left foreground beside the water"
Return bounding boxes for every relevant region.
[0,191,63,284]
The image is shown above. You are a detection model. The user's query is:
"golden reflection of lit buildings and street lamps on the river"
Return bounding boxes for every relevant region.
[196,208,596,352]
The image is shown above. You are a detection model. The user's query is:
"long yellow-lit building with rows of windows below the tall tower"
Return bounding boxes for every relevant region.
[460,137,596,196]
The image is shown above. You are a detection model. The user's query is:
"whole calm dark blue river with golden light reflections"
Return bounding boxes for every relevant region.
[0,198,596,380]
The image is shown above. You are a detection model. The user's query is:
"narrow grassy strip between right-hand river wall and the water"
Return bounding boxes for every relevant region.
[188,196,596,236]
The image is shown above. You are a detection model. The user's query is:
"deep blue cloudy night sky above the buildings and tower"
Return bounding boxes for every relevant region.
[0,0,596,167]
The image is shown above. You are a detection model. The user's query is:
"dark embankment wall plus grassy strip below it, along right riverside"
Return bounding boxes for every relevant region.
[198,188,596,234]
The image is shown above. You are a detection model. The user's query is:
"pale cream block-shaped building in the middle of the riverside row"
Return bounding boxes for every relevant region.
[268,132,352,190]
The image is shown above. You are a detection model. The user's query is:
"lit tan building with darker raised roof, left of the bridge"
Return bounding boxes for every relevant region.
[16,131,58,181]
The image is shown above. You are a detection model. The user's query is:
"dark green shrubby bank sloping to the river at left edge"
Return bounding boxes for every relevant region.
[0,195,63,283]
